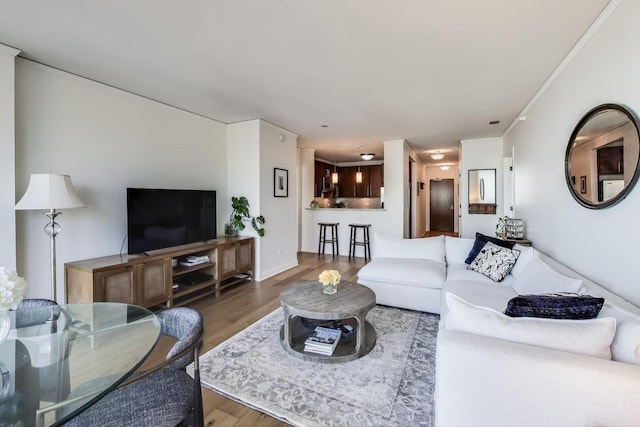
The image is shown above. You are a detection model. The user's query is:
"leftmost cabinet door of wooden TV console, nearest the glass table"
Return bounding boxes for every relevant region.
[93,266,138,304]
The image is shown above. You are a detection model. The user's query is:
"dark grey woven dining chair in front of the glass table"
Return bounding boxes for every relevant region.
[65,307,204,427]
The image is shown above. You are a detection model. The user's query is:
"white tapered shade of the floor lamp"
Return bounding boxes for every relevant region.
[15,173,86,210]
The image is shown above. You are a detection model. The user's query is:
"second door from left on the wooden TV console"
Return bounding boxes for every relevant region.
[136,258,173,307]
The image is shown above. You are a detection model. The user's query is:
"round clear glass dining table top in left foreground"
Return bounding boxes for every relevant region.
[0,303,160,426]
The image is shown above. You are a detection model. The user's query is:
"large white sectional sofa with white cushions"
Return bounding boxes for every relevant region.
[358,235,640,426]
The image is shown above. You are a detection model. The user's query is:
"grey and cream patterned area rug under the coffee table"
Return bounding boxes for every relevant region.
[200,306,439,427]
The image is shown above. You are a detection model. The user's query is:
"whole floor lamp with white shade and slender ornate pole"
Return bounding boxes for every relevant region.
[15,173,86,301]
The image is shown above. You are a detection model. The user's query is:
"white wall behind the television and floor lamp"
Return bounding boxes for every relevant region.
[15,59,227,301]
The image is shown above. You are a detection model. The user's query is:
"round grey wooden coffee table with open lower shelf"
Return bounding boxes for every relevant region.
[280,281,376,363]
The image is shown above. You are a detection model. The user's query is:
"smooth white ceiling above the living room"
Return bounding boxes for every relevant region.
[0,0,608,163]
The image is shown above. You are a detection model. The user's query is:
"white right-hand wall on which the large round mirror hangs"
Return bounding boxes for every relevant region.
[504,0,640,304]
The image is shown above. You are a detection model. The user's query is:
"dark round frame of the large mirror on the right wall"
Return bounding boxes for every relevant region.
[564,104,640,209]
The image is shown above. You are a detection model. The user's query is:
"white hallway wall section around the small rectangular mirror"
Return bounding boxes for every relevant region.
[460,138,504,237]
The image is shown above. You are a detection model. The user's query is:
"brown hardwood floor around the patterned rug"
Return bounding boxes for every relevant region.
[143,252,365,427]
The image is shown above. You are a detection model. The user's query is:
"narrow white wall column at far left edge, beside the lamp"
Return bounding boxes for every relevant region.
[0,45,23,274]
